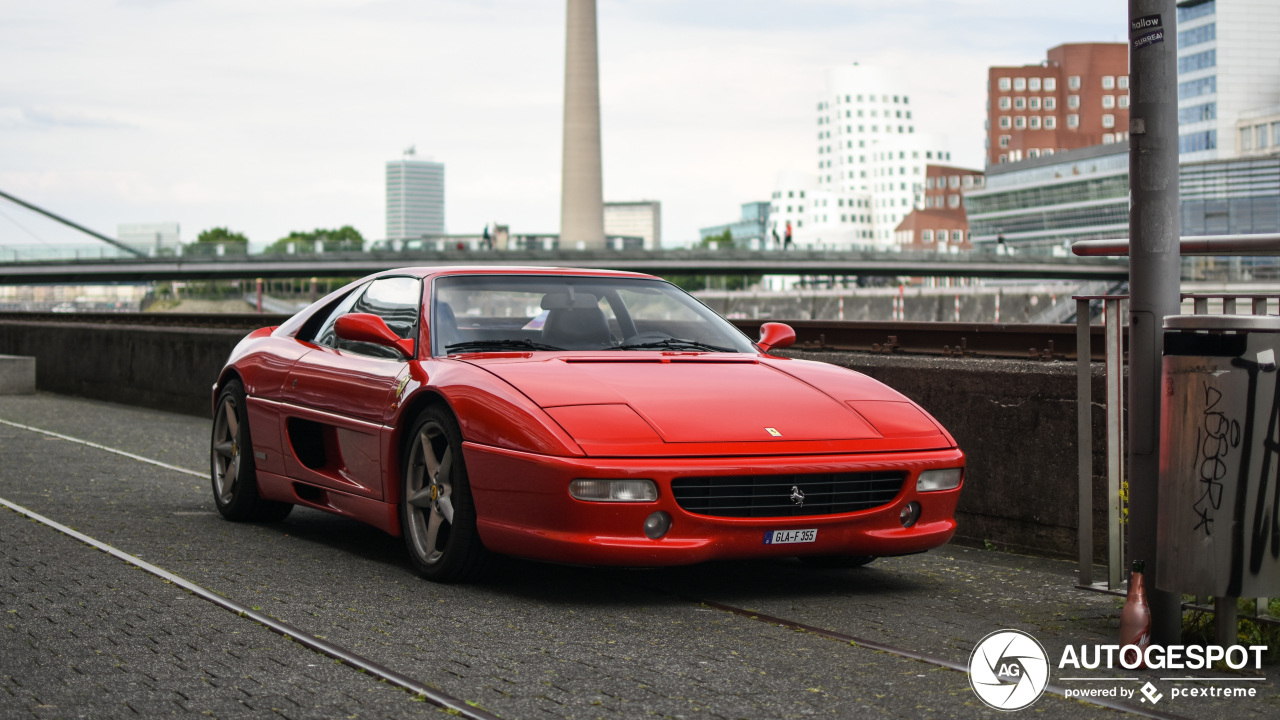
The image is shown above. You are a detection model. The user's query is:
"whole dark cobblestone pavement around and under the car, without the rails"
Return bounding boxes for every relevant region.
[0,395,1280,719]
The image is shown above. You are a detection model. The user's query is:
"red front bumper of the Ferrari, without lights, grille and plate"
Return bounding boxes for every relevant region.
[463,443,964,566]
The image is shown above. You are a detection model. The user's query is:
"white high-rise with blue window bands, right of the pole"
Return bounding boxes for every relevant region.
[1178,0,1280,163]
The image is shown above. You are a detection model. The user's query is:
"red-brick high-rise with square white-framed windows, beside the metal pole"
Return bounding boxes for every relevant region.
[987,42,1129,165]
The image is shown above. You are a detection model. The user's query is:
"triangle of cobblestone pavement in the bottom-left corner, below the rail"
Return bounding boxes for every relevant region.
[0,510,442,719]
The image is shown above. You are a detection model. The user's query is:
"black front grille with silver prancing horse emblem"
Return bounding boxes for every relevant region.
[671,471,906,518]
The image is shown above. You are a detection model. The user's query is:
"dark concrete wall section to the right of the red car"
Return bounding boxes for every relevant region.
[783,351,1106,561]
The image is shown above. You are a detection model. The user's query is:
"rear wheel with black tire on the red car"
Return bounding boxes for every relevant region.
[209,380,293,523]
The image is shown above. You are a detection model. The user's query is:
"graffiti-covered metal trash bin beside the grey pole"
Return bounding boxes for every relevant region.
[1156,315,1280,597]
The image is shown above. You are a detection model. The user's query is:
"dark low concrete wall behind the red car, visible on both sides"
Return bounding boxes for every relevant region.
[0,322,1106,559]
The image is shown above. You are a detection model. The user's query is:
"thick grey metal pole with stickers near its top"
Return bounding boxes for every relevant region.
[1128,0,1181,644]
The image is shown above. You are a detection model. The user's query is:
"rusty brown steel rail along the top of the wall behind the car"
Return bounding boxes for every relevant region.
[0,313,1105,360]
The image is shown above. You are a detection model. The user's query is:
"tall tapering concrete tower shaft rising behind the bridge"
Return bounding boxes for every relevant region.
[561,0,604,250]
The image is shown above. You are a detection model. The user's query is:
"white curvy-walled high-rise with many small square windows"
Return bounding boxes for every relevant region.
[769,64,951,249]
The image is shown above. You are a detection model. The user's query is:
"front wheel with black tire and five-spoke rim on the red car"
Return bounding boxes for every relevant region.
[399,405,490,583]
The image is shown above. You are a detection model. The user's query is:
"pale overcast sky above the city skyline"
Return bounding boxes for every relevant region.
[0,0,1126,252]
